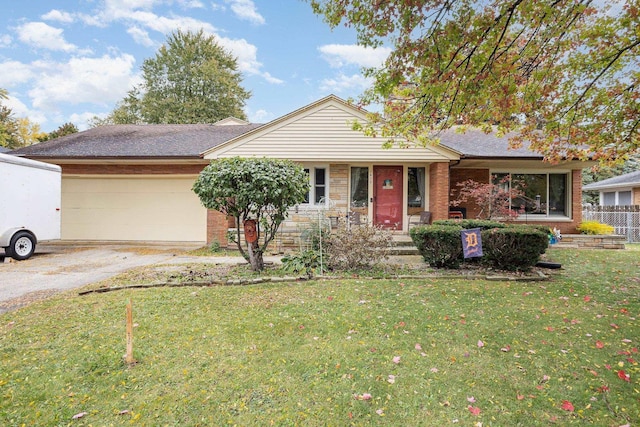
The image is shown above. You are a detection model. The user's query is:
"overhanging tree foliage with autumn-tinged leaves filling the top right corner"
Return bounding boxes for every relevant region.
[309,0,640,165]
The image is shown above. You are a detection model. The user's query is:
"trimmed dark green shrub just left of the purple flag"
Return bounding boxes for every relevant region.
[409,223,463,268]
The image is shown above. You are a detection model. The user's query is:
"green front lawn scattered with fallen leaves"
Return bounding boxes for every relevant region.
[0,245,640,426]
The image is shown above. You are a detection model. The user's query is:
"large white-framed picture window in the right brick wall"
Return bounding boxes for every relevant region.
[493,173,569,216]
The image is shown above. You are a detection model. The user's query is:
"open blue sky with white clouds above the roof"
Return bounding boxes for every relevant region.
[0,0,388,132]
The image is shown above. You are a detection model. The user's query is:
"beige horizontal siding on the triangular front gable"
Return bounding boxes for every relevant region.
[205,102,457,163]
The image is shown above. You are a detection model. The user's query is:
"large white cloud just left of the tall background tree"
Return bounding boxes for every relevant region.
[29,54,136,111]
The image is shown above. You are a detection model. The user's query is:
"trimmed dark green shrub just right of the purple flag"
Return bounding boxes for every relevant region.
[482,226,549,271]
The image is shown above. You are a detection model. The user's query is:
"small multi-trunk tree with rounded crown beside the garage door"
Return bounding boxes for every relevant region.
[193,157,309,271]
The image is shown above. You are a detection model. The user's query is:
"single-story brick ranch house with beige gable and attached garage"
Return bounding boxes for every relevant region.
[8,95,588,243]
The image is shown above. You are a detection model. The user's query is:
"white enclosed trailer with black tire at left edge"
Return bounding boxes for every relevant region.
[0,153,62,260]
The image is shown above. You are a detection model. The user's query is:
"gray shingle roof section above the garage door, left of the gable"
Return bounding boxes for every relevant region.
[11,124,261,158]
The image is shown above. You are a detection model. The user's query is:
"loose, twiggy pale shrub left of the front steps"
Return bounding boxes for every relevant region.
[324,224,392,270]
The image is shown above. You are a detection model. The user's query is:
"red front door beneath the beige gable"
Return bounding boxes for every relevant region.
[373,166,402,230]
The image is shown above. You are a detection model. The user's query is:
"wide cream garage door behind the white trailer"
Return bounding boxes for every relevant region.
[61,176,207,242]
